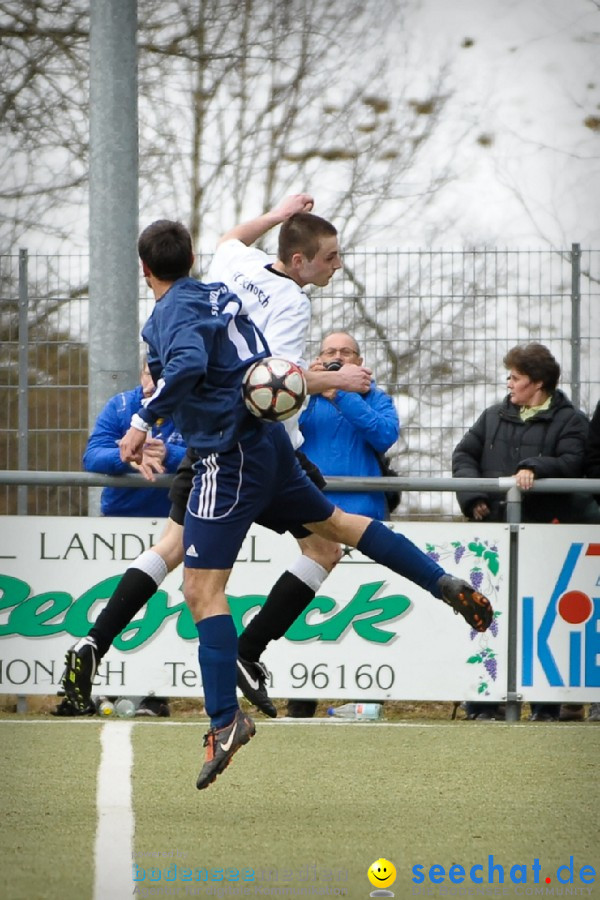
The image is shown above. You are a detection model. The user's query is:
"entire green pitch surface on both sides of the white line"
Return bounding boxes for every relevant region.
[0,720,600,900]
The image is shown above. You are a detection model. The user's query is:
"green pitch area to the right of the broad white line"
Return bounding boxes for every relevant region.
[134,722,600,898]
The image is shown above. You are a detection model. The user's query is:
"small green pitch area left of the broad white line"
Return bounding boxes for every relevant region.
[0,720,102,900]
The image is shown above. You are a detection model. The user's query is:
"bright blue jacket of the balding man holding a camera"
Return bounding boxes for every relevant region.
[300,385,400,519]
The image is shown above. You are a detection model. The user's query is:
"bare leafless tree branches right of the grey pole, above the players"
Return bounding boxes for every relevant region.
[140,0,464,253]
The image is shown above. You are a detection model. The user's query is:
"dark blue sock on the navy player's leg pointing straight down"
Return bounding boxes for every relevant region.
[196,615,239,728]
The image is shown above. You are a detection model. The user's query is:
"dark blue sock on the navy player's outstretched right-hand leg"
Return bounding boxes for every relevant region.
[357,521,446,600]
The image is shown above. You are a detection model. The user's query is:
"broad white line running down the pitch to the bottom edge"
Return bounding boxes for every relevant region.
[94,722,134,900]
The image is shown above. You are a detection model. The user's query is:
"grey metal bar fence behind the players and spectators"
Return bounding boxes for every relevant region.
[0,244,600,518]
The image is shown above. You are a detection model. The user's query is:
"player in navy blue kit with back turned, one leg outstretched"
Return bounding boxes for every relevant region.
[112,221,493,789]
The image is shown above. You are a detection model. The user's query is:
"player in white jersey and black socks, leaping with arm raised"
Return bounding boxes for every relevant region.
[63,194,371,717]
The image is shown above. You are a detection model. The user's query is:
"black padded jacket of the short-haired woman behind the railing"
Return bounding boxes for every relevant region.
[452,390,589,522]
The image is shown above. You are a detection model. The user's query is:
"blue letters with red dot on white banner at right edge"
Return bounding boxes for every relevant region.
[521,543,600,688]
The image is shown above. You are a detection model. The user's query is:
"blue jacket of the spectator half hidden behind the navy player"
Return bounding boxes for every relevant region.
[83,385,185,518]
